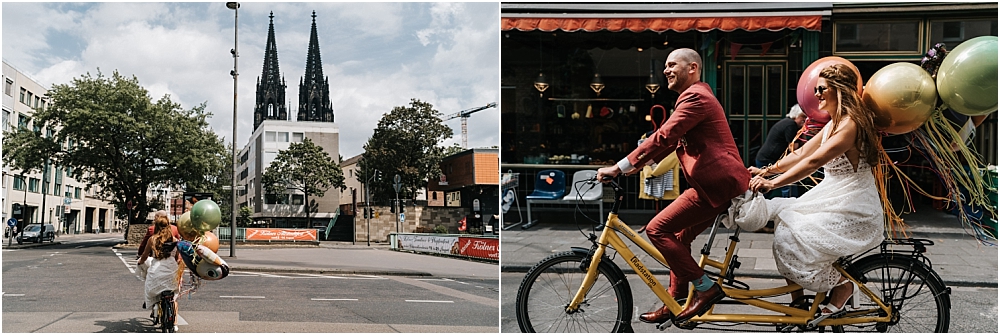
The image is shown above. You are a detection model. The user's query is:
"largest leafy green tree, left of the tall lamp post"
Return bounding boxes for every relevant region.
[3,70,225,224]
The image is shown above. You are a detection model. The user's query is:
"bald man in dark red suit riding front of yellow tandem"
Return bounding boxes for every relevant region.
[597,49,750,324]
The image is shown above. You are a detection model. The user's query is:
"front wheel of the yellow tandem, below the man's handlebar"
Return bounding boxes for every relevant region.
[515,251,632,333]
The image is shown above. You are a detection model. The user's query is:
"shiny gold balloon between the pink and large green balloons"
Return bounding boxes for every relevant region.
[861,63,937,134]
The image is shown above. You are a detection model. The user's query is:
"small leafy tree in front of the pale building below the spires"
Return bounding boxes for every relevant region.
[261,138,347,224]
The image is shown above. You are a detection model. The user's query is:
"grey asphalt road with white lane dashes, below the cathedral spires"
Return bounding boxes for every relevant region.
[2,238,499,333]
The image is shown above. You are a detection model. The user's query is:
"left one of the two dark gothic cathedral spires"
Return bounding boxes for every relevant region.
[253,12,288,130]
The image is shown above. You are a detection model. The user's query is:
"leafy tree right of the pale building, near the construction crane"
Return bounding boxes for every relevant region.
[358,99,452,199]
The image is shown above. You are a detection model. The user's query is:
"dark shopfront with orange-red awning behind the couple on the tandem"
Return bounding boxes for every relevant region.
[500,2,997,212]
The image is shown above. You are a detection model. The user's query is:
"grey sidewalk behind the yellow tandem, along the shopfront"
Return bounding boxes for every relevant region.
[500,208,998,287]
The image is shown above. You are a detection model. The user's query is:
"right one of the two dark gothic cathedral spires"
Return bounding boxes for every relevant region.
[296,11,333,122]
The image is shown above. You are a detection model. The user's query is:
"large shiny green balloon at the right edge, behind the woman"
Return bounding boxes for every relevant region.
[937,36,997,116]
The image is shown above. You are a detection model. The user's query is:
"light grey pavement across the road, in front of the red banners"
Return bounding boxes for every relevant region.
[3,233,500,279]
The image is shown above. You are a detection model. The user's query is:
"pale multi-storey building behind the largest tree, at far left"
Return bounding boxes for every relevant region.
[0,61,120,234]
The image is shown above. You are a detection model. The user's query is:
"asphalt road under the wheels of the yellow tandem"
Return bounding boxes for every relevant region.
[500,272,998,334]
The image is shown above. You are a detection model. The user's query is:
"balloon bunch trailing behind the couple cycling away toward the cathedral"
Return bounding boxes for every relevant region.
[177,200,229,280]
